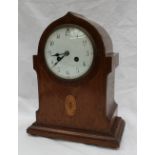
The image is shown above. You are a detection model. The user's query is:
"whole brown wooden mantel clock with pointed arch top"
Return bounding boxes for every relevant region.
[27,12,125,148]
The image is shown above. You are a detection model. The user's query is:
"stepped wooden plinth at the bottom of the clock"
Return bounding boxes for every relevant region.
[27,117,125,148]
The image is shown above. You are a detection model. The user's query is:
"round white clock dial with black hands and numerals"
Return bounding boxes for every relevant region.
[44,25,94,79]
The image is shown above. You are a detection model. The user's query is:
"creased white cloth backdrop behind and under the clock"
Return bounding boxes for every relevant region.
[18,0,137,155]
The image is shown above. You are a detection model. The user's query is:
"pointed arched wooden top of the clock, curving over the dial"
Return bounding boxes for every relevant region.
[38,12,113,55]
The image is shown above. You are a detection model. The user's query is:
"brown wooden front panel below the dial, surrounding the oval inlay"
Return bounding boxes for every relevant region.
[36,61,109,133]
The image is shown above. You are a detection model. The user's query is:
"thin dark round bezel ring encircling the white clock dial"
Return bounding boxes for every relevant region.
[44,24,96,81]
